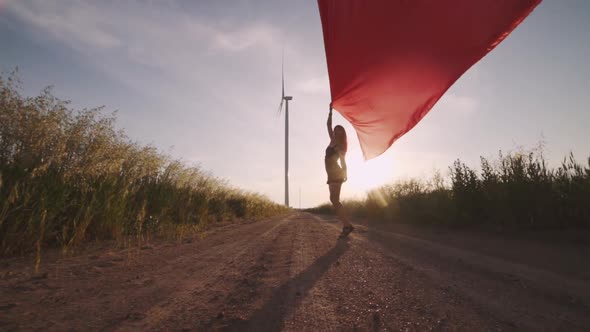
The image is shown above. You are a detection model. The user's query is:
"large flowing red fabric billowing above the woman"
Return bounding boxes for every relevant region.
[318,0,541,159]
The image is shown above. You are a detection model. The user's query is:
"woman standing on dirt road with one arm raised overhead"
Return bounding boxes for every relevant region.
[324,107,354,238]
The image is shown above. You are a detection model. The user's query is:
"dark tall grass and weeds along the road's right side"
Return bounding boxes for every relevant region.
[312,149,590,229]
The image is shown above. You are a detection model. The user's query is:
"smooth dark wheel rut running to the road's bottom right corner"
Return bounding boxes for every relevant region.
[316,217,590,331]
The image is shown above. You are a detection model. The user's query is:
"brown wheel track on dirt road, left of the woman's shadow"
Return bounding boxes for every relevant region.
[120,215,293,330]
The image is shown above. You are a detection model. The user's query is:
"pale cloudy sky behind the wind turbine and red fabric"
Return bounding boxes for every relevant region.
[0,0,590,207]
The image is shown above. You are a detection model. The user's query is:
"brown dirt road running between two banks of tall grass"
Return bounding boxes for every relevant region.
[0,213,590,331]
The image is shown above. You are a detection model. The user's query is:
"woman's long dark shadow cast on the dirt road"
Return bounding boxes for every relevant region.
[223,239,349,331]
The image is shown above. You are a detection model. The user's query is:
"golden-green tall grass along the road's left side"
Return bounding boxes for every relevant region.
[0,73,285,255]
